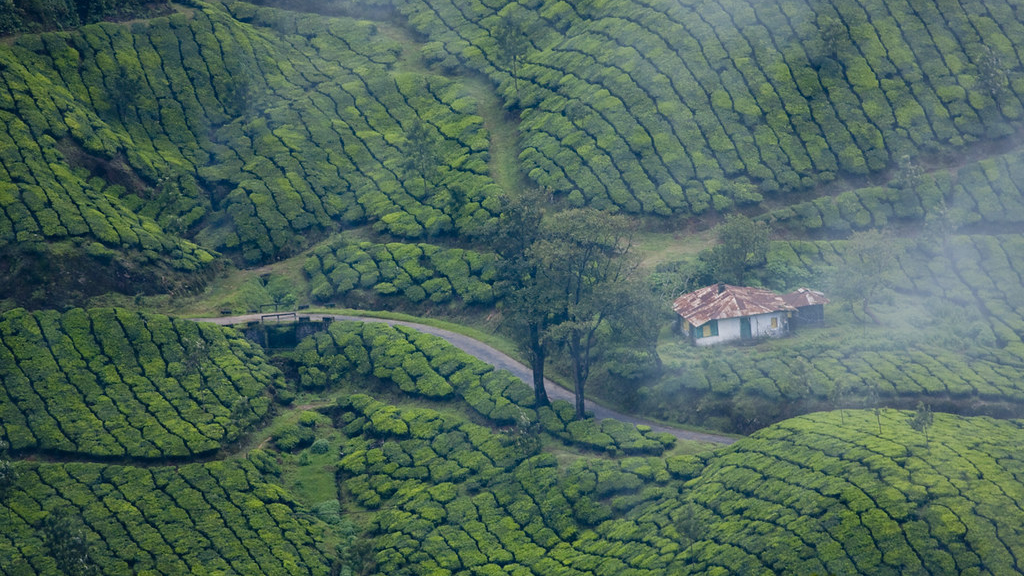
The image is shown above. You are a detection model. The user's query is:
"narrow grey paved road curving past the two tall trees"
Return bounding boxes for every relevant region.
[191,313,736,444]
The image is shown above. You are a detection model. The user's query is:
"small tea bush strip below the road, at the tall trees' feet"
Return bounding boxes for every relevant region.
[537,400,676,454]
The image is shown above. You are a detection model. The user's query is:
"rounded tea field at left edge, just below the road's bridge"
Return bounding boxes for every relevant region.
[0,308,280,458]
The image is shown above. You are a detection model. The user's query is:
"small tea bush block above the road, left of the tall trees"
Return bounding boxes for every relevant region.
[305,240,497,304]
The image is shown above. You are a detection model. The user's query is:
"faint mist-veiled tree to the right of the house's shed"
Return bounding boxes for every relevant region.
[831,230,897,324]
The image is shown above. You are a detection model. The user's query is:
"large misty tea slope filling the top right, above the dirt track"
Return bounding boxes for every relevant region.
[397,0,1024,213]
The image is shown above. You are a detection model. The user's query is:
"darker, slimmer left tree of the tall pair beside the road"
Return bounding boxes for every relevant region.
[493,189,554,406]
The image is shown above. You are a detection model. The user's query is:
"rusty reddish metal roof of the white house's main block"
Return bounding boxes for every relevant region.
[672,284,796,326]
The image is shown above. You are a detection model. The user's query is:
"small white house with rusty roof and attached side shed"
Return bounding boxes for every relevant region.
[672,284,828,346]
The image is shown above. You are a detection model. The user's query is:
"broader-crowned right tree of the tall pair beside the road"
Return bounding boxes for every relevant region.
[528,208,639,418]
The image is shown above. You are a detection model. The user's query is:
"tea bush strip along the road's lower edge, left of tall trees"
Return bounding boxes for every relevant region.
[294,322,537,422]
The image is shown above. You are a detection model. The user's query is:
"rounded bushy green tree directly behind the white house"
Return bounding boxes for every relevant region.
[703,214,771,285]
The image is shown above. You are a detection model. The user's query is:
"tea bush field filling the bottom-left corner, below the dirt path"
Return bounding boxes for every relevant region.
[0,460,331,576]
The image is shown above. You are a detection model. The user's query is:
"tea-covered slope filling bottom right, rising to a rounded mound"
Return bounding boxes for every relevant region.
[323,397,1024,576]
